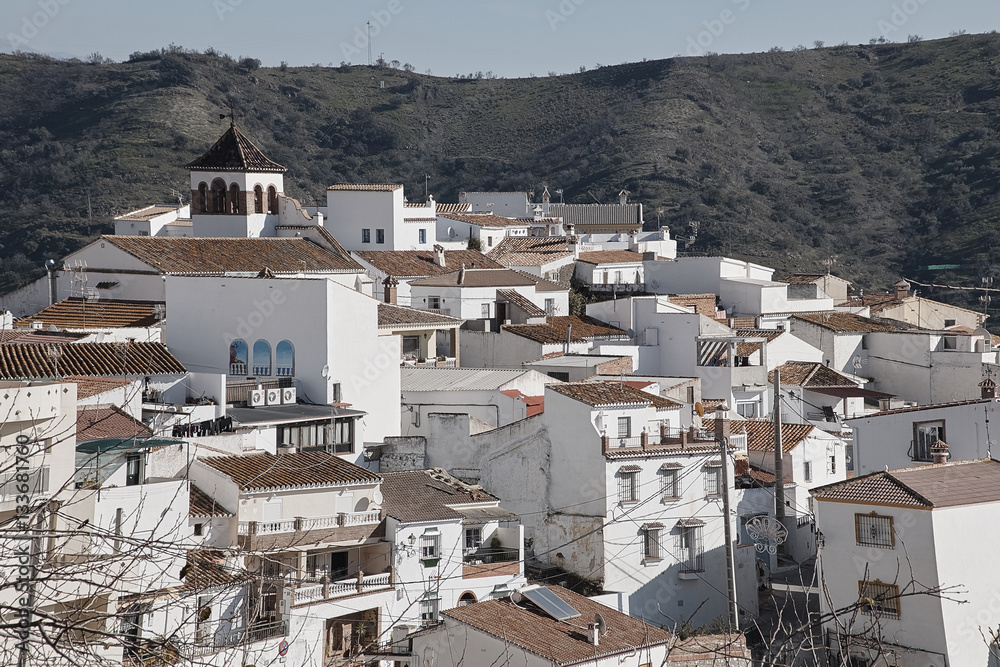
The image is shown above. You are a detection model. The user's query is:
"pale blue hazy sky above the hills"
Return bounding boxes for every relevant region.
[0,0,1000,77]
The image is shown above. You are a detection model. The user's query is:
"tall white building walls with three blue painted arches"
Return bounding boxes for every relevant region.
[166,276,400,456]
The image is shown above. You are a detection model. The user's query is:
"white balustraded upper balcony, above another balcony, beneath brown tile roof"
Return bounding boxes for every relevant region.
[236,510,382,551]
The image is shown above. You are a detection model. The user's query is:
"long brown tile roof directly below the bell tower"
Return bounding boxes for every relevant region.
[100,236,361,275]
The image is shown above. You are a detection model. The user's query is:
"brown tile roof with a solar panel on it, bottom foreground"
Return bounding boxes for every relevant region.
[441,586,688,666]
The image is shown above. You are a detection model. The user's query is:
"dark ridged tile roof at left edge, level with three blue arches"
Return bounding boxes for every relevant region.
[0,342,187,380]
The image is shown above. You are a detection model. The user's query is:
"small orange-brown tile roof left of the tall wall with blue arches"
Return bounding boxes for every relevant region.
[16,297,164,329]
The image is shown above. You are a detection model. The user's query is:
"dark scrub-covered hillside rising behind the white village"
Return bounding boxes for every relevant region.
[0,34,1000,314]
